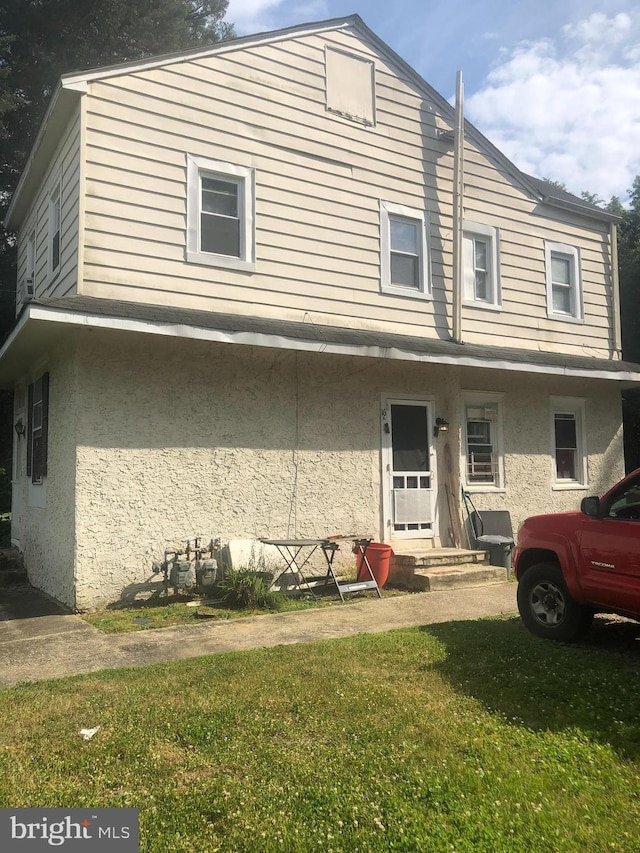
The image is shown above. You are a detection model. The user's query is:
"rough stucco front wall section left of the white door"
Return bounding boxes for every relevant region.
[72,332,460,608]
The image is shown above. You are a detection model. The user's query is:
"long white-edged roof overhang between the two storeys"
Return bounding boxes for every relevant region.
[0,304,640,385]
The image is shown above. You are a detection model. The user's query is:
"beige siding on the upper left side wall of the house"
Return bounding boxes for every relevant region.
[17,107,80,306]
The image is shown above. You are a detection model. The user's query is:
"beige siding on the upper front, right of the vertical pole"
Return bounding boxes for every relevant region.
[463,134,613,357]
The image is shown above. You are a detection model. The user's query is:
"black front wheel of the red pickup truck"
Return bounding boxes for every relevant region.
[518,563,593,642]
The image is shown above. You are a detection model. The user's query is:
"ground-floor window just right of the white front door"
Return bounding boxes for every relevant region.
[463,392,504,491]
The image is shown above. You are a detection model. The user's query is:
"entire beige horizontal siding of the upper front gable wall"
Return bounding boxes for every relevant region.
[82,24,611,355]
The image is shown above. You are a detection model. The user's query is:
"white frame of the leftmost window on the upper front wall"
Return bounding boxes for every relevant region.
[185,154,256,272]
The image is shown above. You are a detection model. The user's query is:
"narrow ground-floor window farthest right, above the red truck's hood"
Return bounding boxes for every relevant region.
[551,397,587,488]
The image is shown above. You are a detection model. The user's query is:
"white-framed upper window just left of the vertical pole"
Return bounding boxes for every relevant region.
[380,201,431,298]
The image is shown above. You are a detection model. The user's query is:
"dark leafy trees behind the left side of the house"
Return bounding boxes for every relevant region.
[0,0,234,512]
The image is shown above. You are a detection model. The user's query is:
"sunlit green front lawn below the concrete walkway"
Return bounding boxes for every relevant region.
[0,619,640,853]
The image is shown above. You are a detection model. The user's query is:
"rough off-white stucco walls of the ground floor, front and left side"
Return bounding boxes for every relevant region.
[15,330,622,609]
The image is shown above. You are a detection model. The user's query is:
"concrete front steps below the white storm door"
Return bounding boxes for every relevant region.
[389,548,507,590]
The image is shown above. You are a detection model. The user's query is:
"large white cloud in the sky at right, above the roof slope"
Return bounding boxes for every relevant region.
[467,13,640,199]
